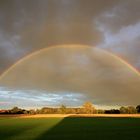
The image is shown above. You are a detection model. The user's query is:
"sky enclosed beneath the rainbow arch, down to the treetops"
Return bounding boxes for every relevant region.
[0,45,140,107]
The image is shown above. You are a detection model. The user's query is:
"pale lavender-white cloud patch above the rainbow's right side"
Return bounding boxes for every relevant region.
[98,19,140,69]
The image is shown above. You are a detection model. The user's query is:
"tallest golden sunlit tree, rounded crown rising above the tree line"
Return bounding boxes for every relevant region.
[83,102,96,114]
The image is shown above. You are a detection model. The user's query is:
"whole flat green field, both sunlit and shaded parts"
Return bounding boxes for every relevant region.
[0,117,140,140]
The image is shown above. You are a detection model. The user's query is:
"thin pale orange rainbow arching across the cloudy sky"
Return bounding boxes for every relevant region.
[0,44,140,80]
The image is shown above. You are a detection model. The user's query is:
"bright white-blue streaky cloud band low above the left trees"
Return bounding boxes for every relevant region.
[0,87,86,108]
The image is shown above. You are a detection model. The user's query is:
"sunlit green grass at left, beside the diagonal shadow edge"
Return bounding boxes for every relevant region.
[0,118,62,140]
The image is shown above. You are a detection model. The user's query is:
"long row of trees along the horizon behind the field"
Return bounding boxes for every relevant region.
[0,102,140,114]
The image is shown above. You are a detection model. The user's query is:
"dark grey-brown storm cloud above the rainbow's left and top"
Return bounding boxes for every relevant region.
[0,0,119,72]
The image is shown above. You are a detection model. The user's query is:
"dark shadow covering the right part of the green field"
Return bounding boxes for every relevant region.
[36,117,140,140]
